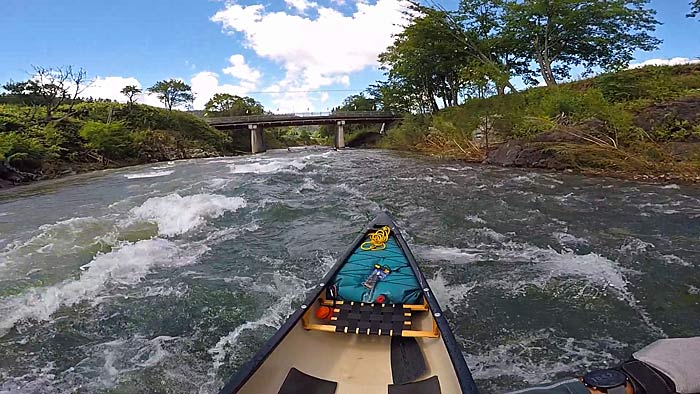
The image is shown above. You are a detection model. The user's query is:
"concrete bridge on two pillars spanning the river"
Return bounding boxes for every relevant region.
[204,111,403,153]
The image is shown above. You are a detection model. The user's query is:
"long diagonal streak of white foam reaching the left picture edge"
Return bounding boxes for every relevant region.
[0,238,204,337]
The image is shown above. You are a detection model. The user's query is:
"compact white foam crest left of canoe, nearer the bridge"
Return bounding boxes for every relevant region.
[131,193,246,236]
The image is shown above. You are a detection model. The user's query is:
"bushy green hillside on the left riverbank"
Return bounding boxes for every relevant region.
[0,102,246,185]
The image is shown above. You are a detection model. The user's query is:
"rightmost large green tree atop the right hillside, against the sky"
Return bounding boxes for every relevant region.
[504,0,661,86]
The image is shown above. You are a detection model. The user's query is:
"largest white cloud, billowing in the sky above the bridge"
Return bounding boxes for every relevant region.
[211,0,406,111]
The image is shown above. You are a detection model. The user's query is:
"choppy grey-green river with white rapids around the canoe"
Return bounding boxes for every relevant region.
[0,149,700,394]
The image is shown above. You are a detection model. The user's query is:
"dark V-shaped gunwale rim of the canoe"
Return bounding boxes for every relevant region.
[219,212,477,394]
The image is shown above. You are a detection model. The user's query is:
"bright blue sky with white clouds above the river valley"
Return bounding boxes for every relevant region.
[0,0,700,112]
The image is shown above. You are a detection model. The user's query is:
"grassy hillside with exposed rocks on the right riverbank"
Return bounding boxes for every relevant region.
[382,65,700,181]
